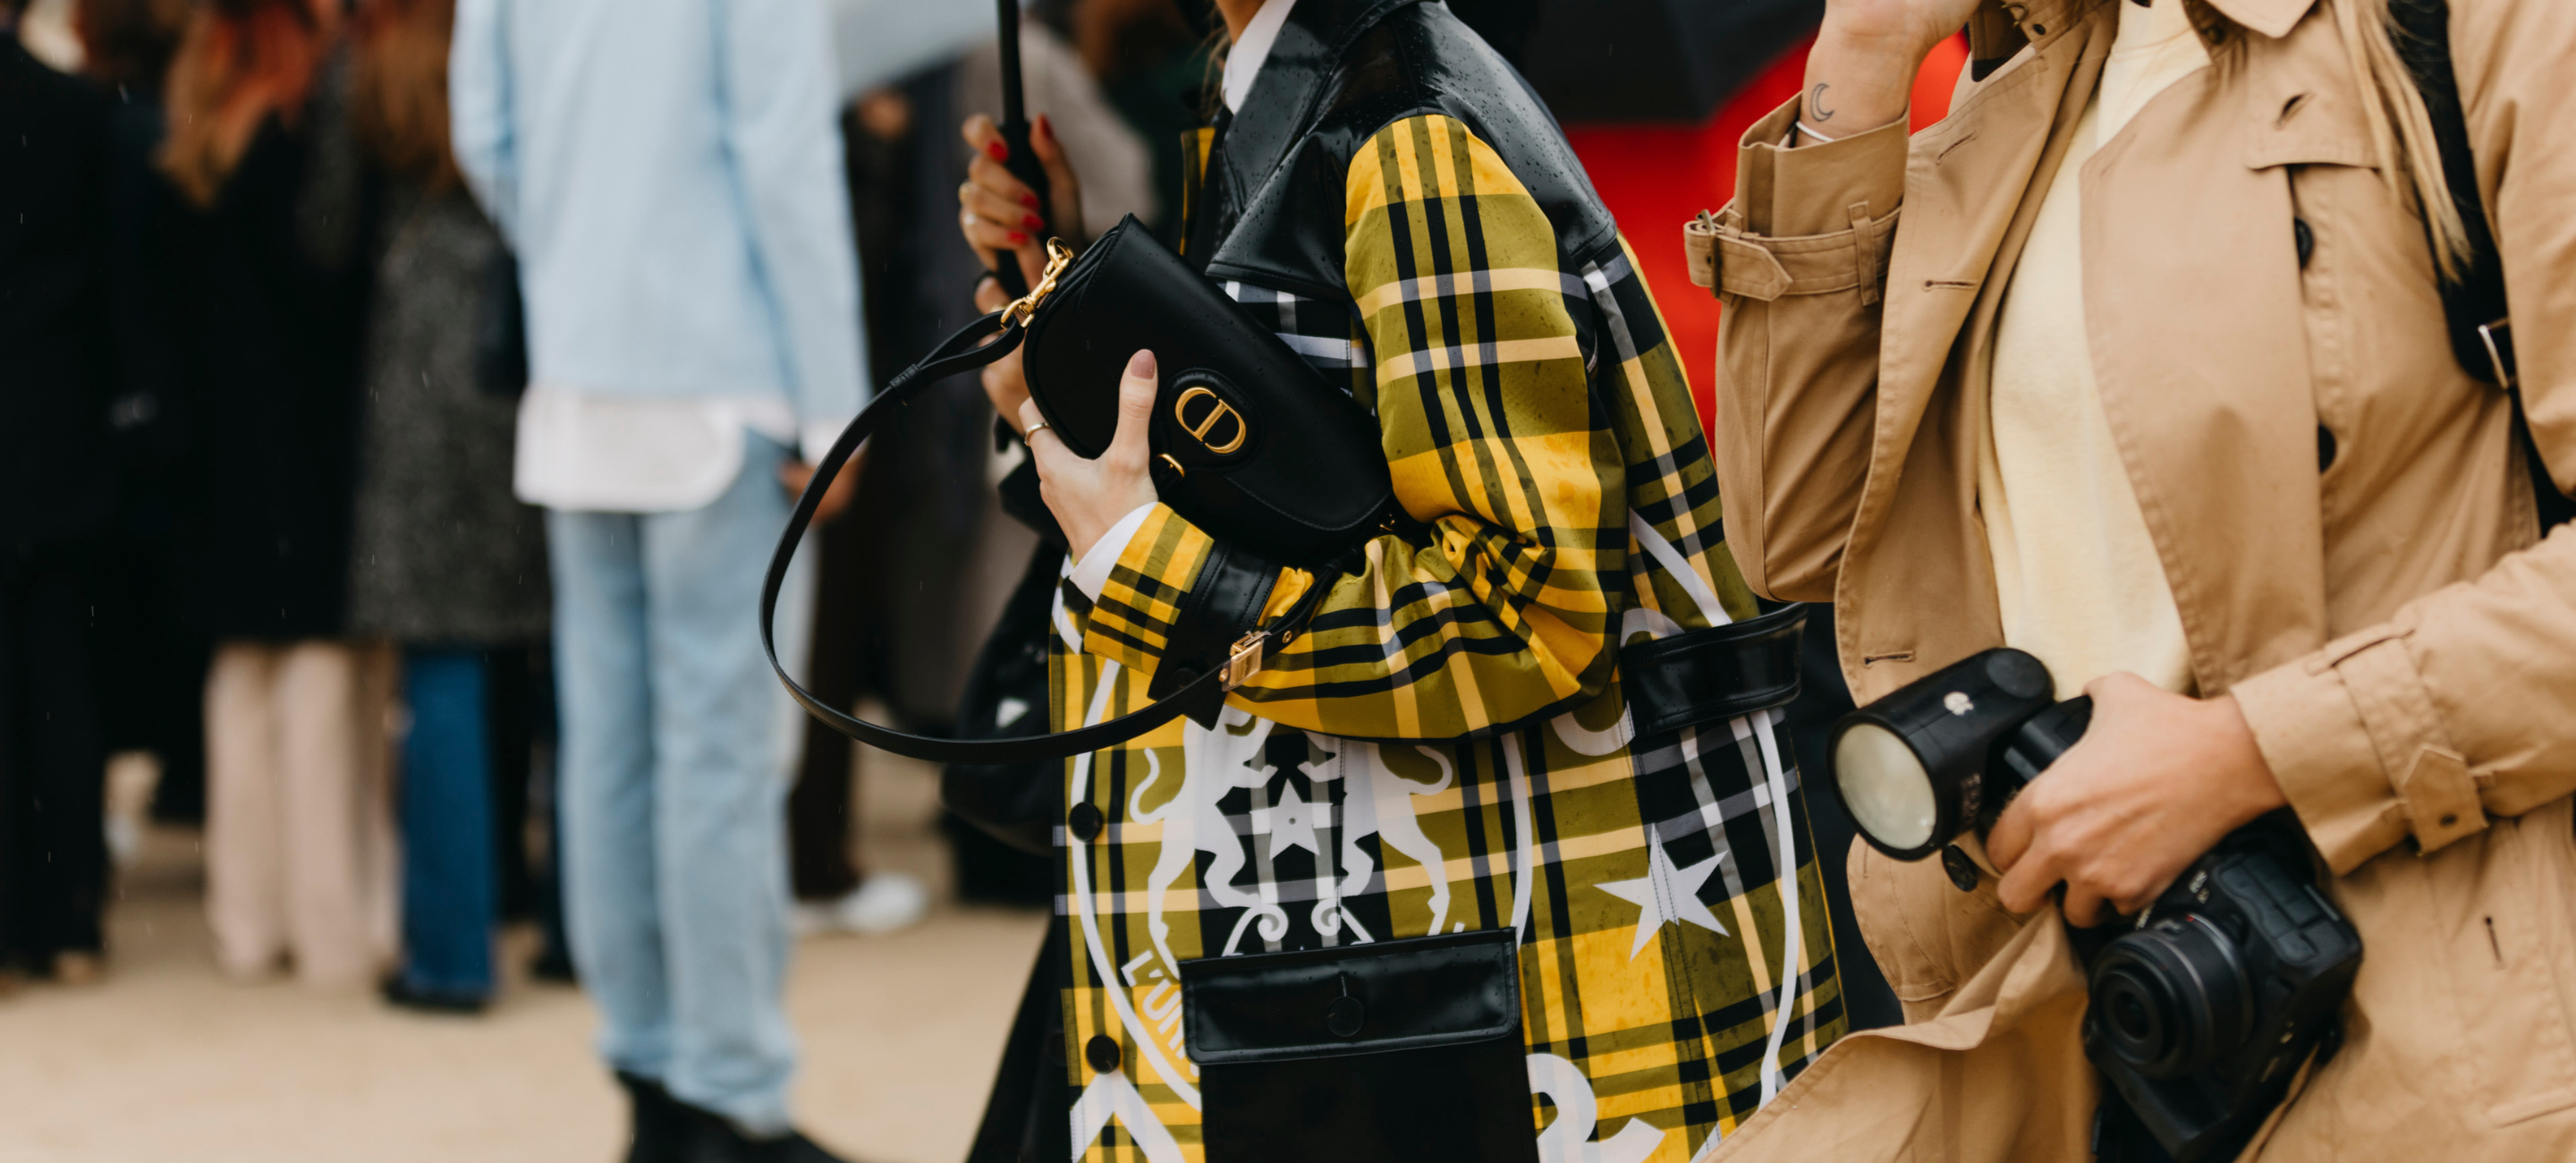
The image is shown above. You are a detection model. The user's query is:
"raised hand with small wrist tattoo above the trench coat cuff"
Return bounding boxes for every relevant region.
[1798,0,1994,144]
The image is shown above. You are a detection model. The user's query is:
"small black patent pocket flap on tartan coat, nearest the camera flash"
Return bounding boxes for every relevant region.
[1618,606,1806,735]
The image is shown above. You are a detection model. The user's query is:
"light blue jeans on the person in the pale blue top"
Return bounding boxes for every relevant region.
[547,438,804,1134]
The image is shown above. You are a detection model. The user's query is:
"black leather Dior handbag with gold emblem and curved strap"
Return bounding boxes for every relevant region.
[760,216,1396,763]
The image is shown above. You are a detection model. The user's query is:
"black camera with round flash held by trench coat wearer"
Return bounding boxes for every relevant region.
[1832,649,2362,1163]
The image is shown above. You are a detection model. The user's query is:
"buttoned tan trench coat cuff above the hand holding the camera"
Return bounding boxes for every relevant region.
[2233,626,2486,874]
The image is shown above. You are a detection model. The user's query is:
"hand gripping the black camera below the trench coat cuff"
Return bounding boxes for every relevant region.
[1986,673,2287,926]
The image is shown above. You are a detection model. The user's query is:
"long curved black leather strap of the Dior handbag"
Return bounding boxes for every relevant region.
[760,312,1332,763]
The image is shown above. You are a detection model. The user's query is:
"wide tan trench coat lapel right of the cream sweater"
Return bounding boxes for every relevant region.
[2084,70,2326,693]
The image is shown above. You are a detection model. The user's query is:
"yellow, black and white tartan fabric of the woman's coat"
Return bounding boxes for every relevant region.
[1054,116,1844,1163]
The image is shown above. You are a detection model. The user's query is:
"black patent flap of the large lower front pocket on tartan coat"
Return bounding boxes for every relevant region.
[1180,929,1520,1065]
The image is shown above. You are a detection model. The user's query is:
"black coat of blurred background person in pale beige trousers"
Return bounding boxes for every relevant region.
[157,82,369,640]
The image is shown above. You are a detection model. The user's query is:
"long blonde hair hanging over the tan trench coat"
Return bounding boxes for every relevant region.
[2184,0,2468,278]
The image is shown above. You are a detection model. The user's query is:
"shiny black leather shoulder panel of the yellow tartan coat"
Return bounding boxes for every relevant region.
[1208,0,1618,299]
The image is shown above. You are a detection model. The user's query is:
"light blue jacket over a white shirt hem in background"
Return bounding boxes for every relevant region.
[448,0,869,428]
